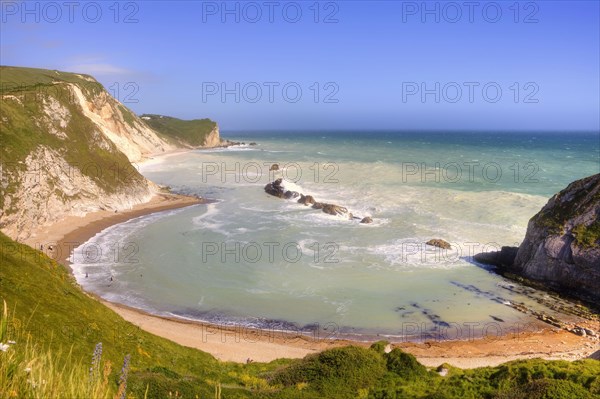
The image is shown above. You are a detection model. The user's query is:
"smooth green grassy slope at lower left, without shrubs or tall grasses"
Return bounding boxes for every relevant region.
[0,233,288,397]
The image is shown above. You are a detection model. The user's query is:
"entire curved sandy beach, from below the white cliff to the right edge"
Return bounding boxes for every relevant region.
[21,188,600,368]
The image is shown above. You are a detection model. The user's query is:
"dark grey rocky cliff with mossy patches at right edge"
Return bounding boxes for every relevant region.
[508,174,600,300]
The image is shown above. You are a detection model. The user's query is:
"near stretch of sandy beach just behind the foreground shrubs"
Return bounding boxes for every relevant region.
[97,298,598,369]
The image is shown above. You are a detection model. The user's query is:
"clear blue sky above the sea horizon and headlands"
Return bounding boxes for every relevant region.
[0,0,600,131]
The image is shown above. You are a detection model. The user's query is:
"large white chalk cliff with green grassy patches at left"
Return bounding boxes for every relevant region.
[0,67,174,240]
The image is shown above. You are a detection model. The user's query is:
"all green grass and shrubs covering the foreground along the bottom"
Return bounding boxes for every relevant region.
[0,234,600,399]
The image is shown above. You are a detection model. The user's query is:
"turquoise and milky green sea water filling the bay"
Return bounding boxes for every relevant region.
[74,131,599,338]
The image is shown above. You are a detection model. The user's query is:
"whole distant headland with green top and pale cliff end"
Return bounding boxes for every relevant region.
[141,114,228,148]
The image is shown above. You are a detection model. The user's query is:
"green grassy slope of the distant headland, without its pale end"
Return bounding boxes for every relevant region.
[142,114,217,146]
